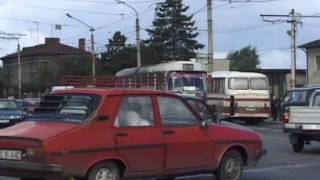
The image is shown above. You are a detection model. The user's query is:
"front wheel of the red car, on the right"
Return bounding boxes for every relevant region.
[215,150,243,180]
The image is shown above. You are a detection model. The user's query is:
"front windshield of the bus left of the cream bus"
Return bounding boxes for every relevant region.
[172,73,205,91]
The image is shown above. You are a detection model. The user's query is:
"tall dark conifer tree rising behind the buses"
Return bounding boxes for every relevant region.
[145,0,204,61]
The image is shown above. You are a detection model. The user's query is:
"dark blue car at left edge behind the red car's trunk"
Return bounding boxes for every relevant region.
[0,99,26,127]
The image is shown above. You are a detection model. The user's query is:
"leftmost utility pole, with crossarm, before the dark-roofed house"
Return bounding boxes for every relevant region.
[0,32,25,99]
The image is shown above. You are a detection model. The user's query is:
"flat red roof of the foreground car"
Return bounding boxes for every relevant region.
[52,88,175,96]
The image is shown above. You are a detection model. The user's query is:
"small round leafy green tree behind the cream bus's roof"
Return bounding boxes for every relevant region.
[227,46,260,72]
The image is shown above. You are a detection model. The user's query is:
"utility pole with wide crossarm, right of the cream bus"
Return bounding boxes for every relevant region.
[260,9,320,89]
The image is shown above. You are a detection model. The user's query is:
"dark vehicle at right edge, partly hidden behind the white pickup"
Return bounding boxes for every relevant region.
[280,85,320,123]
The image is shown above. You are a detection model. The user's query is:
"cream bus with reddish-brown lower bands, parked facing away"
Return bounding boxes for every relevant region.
[207,71,270,121]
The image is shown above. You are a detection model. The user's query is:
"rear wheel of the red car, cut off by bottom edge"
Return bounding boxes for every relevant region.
[87,162,120,180]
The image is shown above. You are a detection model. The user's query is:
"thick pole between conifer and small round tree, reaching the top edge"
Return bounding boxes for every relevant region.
[207,0,214,72]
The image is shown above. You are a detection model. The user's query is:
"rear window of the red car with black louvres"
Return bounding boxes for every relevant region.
[28,94,100,122]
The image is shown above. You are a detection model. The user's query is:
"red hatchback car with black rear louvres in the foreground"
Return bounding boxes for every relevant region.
[0,89,266,180]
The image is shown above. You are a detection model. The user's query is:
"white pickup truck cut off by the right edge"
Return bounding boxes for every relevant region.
[284,90,320,152]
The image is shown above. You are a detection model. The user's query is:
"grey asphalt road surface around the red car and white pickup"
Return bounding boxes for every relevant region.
[0,121,320,180]
